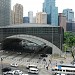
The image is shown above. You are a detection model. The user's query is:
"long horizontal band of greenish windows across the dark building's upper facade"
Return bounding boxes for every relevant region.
[0,28,59,33]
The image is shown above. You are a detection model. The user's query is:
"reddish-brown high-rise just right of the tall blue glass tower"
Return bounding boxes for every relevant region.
[58,13,67,31]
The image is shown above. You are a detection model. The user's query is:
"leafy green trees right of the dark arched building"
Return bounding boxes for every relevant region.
[64,32,75,58]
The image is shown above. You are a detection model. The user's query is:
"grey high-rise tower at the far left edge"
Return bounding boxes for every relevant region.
[0,0,11,26]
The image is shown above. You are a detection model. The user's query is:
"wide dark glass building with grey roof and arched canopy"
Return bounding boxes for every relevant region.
[0,23,64,54]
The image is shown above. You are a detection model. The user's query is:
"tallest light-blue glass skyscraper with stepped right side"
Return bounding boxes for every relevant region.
[43,0,58,26]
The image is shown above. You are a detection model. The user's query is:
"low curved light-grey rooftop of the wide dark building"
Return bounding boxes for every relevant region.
[0,23,60,28]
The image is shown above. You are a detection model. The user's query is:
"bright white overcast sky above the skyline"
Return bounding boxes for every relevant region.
[11,0,75,16]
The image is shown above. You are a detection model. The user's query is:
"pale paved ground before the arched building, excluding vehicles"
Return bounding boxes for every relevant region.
[0,51,73,75]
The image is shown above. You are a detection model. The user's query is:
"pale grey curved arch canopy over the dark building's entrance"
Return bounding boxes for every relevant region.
[7,34,61,54]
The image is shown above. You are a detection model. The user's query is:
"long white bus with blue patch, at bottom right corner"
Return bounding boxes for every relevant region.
[52,64,75,75]
